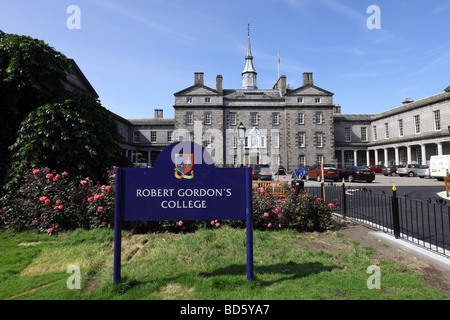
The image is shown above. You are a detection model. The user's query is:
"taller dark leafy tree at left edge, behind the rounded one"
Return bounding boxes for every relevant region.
[0,30,71,186]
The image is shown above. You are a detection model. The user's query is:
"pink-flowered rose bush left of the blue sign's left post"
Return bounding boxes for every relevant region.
[0,168,114,234]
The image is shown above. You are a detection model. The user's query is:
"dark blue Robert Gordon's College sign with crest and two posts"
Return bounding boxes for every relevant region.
[114,142,253,283]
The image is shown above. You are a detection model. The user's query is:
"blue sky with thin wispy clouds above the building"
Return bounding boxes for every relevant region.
[0,0,450,118]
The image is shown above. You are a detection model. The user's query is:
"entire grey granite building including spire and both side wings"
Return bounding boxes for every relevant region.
[109,35,450,170]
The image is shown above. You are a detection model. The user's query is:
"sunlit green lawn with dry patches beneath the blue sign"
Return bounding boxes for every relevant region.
[0,227,449,300]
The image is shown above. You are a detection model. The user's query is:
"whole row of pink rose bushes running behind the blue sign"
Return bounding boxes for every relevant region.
[0,168,338,234]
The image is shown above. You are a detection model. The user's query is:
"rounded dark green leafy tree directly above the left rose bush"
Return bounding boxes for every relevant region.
[6,93,131,191]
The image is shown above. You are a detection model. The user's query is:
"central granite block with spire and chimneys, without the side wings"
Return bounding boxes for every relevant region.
[174,33,335,170]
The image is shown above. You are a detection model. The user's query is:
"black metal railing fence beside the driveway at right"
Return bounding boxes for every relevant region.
[305,184,450,258]
